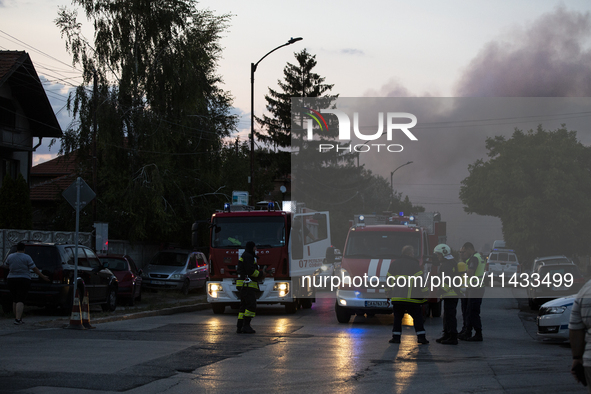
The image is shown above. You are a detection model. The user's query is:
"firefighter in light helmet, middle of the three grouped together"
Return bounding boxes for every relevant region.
[433,244,460,345]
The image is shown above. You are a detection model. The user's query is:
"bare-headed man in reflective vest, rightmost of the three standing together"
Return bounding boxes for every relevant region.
[458,242,485,342]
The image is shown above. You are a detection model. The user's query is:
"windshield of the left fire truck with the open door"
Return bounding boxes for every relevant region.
[211,216,285,248]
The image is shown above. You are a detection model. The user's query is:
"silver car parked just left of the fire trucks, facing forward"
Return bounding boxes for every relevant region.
[142,249,209,294]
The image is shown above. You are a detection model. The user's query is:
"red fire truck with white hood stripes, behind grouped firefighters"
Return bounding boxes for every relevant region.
[335,213,445,323]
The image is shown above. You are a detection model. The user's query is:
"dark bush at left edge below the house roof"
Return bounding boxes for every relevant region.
[0,172,33,230]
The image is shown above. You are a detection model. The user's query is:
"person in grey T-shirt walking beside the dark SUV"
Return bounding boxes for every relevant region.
[5,242,49,325]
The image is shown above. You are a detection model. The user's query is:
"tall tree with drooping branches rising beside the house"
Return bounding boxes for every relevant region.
[56,0,236,241]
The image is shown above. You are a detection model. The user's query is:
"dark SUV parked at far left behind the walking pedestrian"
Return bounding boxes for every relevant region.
[0,241,118,313]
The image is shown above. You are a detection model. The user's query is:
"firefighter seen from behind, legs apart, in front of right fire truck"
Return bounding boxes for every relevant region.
[388,245,429,345]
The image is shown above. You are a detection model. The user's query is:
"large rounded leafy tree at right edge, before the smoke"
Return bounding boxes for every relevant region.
[460,125,591,262]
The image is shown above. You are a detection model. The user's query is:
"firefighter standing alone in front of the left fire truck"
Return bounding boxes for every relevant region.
[236,241,265,334]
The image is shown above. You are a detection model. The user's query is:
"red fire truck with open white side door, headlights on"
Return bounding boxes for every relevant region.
[207,203,331,314]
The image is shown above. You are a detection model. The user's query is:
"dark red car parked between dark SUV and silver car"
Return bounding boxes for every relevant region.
[99,254,143,305]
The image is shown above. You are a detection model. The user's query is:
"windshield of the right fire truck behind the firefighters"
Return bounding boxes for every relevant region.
[344,231,421,259]
